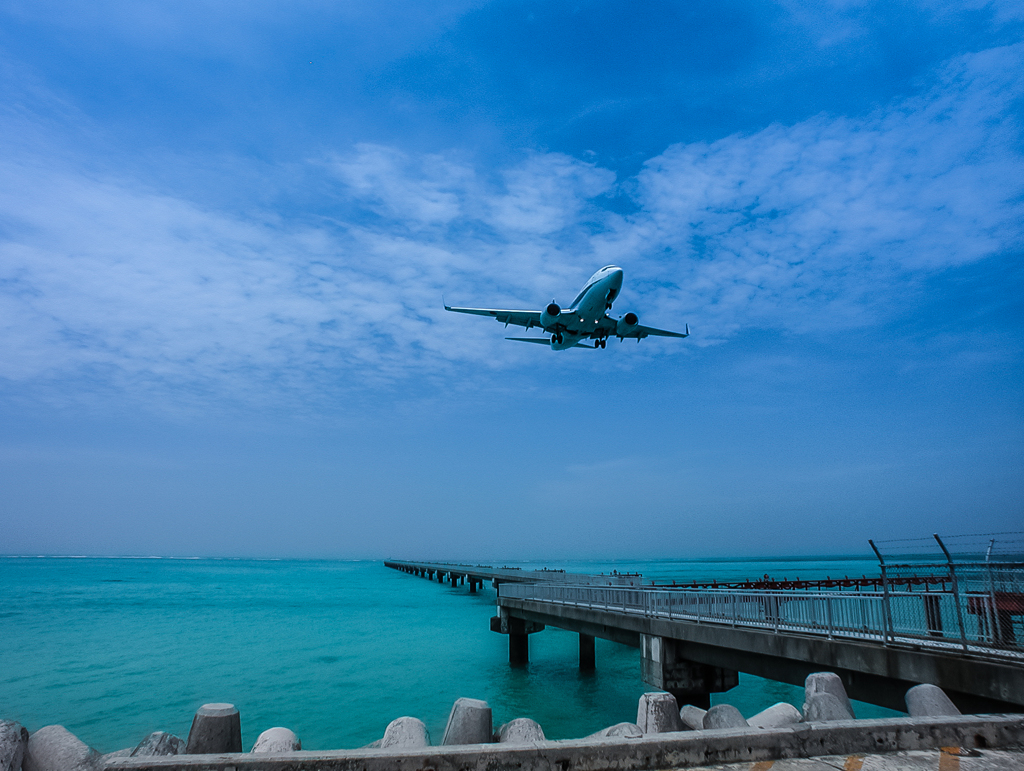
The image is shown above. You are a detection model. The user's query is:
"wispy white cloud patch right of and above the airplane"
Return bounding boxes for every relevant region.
[626,46,1024,337]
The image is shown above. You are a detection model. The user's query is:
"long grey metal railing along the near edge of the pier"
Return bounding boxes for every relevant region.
[499,584,1024,658]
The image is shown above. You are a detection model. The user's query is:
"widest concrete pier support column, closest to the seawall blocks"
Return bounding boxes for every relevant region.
[640,635,739,710]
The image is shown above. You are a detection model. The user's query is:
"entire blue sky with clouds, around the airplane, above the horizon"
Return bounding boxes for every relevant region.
[0,0,1024,559]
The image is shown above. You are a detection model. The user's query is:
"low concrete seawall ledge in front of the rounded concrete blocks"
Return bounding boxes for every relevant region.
[104,715,1024,771]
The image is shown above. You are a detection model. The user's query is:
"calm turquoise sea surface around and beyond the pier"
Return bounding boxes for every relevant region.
[0,557,896,753]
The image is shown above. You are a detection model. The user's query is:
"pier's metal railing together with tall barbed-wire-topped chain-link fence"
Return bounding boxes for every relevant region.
[499,537,1024,658]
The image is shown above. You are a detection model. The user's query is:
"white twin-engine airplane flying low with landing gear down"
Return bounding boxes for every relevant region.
[442,265,690,351]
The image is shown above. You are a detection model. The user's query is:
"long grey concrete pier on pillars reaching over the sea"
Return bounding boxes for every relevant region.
[385,563,1024,713]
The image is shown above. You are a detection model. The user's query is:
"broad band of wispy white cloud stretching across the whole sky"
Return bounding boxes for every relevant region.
[0,45,1024,405]
